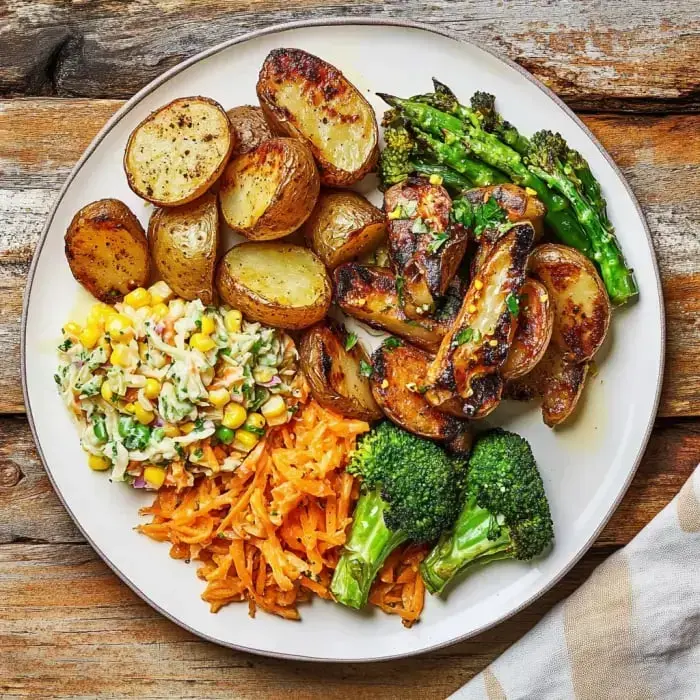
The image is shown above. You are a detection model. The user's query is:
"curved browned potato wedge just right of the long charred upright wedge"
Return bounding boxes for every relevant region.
[501,278,554,379]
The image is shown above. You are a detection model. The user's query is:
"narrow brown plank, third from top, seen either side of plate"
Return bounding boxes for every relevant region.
[0,416,700,546]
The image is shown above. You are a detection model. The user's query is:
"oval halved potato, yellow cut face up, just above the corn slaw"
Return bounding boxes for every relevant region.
[216,242,332,328]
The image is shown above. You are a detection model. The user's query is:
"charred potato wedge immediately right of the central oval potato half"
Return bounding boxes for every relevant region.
[333,263,449,352]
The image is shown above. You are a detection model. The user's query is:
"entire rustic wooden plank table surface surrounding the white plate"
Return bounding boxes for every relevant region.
[0,0,700,699]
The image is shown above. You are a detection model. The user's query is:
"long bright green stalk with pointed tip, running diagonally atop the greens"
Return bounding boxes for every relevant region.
[380,95,593,259]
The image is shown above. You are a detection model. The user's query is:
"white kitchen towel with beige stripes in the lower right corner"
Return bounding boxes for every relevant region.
[451,467,700,700]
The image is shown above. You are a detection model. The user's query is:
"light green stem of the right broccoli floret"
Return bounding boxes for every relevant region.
[421,499,513,594]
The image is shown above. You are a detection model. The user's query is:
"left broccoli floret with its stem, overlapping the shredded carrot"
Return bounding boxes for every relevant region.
[331,421,463,608]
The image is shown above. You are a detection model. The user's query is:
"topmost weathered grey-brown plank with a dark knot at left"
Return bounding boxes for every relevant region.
[0,0,700,111]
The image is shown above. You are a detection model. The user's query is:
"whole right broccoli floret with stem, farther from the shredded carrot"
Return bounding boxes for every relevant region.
[421,430,554,593]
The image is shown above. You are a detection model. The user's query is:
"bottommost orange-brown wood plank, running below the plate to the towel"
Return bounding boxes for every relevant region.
[0,544,614,700]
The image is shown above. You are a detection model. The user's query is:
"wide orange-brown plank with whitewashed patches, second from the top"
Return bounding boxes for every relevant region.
[0,99,700,416]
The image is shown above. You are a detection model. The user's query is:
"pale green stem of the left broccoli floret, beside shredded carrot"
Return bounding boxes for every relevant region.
[331,490,408,608]
